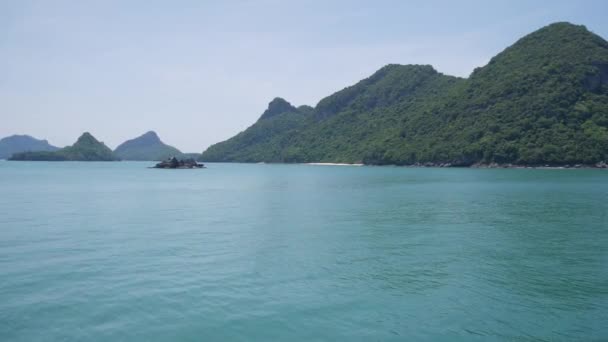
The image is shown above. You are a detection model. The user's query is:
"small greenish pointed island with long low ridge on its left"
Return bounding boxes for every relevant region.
[10,132,119,161]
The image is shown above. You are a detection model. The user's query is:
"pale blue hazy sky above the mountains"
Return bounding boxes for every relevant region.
[0,0,608,152]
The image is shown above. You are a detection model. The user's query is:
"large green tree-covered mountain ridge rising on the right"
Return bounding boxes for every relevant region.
[201,23,608,166]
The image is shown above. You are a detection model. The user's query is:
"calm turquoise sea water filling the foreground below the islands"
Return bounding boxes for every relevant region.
[0,162,608,341]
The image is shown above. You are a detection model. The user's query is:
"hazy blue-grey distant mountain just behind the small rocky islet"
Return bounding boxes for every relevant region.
[114,131,182,160]
